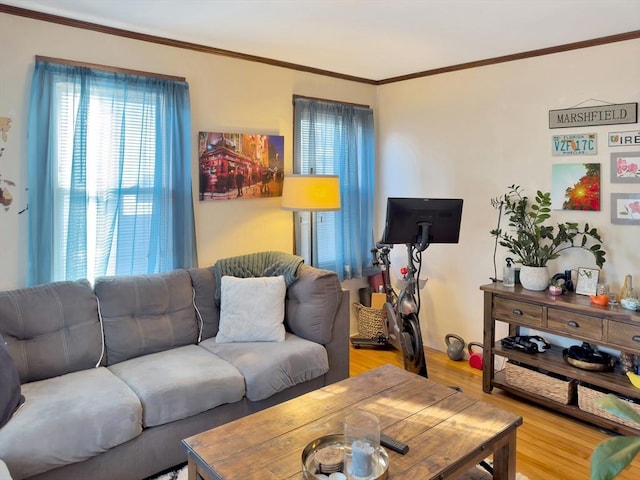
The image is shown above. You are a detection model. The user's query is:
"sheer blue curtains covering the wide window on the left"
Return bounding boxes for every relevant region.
[28,59,197,285]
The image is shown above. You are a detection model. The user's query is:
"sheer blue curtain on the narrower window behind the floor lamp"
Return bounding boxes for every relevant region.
[294,97,375,280]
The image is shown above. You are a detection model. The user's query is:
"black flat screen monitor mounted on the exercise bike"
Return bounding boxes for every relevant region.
[381,197,462,250]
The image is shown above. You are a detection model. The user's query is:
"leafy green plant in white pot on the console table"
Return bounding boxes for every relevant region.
[491,185,605,290]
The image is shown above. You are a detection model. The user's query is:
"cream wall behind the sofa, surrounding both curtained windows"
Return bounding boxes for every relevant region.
[0,13,376,289]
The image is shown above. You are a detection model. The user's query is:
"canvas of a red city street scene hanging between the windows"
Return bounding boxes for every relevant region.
[198,132,284,201]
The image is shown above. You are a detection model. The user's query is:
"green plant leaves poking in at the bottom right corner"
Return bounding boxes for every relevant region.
[591,394,640,480]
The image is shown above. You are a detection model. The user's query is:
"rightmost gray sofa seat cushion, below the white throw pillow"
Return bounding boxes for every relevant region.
[200,333,329,401]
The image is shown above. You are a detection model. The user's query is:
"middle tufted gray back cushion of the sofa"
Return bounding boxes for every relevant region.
[94,270,198,365]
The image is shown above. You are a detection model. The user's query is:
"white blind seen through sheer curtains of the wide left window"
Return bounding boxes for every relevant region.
[54,82,156,280]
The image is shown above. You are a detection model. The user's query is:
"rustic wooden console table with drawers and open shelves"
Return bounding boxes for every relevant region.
[480,283,640,435]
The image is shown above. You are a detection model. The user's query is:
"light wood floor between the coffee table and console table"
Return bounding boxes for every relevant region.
[350,346,640,480]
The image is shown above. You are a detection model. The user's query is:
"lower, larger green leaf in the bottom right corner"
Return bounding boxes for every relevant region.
[591,437,640,480]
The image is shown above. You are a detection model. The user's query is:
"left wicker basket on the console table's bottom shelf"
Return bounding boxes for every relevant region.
[505,360,576,405]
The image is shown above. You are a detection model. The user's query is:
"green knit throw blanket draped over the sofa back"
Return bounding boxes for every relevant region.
[213,252,304,305]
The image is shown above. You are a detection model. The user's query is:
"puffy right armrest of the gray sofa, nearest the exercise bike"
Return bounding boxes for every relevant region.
[285,265,349,384]
